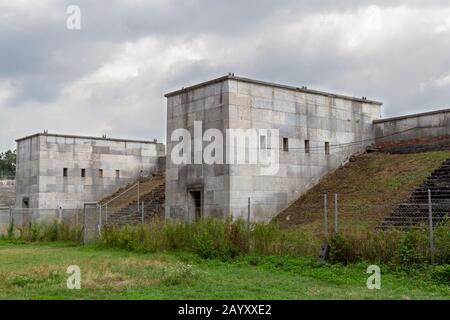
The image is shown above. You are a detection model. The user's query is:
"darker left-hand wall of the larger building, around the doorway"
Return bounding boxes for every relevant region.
[166,82,229,220]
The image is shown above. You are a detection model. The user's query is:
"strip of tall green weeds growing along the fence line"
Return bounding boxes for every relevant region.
[4,218,450,270]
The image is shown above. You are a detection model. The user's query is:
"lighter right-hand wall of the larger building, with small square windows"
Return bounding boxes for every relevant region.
[229,80,380,221]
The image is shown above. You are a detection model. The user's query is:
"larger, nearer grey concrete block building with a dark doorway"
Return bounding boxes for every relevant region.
[166,75,382,221]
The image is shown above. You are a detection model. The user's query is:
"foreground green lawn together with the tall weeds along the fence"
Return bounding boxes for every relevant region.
[0,219,450,299]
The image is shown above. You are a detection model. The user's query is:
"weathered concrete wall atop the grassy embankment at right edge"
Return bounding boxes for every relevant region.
[374,109,450,153]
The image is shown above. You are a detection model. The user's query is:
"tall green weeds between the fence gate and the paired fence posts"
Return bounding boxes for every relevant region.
[99,218,320,261]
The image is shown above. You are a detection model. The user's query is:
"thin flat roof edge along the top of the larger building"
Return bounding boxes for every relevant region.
[164,75,383,105]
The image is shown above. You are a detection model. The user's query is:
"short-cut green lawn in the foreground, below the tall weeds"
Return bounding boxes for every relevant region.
[0,241,450,299]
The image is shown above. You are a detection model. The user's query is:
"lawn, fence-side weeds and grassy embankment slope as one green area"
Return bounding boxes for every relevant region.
[0,151,450,299]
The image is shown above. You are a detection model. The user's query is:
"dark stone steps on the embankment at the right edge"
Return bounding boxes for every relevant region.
[379,159,450,229]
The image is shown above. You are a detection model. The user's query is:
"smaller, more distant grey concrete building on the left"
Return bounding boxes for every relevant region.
[15,133,165,209]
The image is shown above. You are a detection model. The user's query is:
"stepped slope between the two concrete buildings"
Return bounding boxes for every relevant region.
[102,171,165,226]
